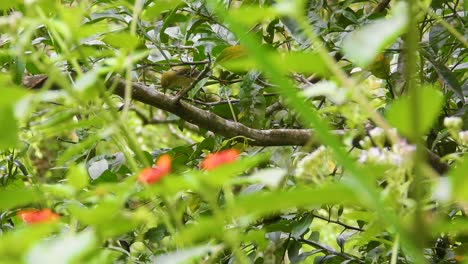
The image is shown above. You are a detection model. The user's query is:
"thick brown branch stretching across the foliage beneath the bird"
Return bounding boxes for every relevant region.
[22,75,448,174]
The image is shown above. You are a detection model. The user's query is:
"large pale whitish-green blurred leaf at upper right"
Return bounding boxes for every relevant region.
[342,1,408,68]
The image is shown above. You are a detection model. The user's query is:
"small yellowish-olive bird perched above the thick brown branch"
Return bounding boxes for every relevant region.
[161,66,200,93]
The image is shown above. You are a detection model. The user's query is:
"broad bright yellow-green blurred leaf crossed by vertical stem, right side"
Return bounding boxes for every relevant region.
[386,87,443,138]
